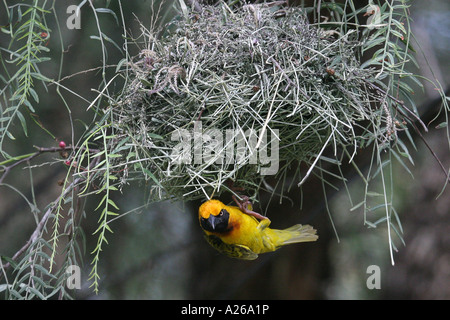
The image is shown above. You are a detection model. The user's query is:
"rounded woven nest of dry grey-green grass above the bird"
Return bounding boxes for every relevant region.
[112,4,390,199]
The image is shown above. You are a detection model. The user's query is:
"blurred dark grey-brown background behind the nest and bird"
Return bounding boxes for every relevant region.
[0,0,450,299]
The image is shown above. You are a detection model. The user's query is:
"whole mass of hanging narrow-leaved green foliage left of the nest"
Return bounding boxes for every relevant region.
[0,0,124,299]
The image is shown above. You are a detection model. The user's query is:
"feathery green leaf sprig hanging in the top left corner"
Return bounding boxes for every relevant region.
[0,0,50,155]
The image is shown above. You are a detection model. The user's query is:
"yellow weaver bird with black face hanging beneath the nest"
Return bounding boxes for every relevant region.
[198,199,318,260]
